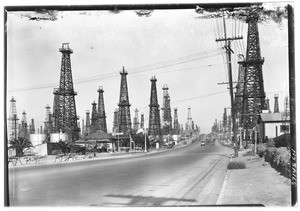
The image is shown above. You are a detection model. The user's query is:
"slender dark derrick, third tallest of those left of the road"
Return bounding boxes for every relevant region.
[148,76,160,136]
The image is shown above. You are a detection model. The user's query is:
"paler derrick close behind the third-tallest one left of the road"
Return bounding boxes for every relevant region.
[161,84,172,135]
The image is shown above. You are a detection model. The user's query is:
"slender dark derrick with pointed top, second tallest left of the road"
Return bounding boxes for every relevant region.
[118,67,131,133]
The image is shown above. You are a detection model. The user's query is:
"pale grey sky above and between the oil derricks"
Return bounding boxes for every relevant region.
[7,4,289,133]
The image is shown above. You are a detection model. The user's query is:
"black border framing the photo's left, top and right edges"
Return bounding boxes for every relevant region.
[3,2,297,207]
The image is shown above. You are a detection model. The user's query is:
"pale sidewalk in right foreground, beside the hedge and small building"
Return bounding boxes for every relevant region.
[217,150,291,207]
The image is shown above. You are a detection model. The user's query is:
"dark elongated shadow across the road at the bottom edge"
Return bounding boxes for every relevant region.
[91,194,194,207]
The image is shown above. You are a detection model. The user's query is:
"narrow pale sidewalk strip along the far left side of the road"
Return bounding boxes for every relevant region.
[9,141,191,168]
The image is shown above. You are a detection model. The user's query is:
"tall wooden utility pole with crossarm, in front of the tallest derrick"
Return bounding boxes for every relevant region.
[216,16,243,157]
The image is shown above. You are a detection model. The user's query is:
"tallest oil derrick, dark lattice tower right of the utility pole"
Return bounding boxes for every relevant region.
[239,11,266,134]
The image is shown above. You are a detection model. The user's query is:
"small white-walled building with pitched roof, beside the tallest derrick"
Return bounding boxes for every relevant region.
[258,113,290,140]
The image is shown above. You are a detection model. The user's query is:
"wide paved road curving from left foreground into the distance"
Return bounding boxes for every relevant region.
[9,142,232,206]
